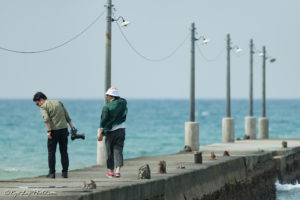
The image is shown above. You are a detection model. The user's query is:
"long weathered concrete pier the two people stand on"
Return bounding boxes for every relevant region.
[0,139,300,200]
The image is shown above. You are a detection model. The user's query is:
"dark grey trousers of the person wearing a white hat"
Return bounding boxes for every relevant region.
[105,128,125,170]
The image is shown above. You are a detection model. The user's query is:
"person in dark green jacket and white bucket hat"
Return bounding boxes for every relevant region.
[97,87,127,178]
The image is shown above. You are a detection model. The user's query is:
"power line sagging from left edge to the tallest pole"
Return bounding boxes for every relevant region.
[0,10,105,54]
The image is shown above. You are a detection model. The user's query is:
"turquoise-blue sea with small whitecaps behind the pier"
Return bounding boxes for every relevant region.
[0,99,300,200]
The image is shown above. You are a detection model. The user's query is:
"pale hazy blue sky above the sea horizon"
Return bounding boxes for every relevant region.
[0,0,300,99]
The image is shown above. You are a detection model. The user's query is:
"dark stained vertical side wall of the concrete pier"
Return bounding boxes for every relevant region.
[78,148,300,200]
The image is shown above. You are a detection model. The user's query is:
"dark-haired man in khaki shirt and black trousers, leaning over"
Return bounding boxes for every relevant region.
[33,92,74,178]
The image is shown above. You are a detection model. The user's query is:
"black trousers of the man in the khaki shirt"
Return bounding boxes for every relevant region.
[48,128,69,173]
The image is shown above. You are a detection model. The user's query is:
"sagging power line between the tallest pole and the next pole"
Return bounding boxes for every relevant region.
[117,23,189,62]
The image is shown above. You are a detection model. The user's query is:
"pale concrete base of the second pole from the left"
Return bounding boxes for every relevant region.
[184,122,199,151]
